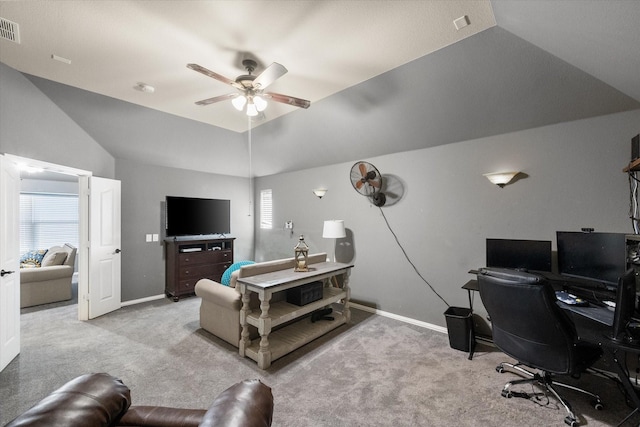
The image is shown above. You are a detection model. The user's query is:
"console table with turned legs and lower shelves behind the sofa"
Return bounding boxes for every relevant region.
[238,262,353,369]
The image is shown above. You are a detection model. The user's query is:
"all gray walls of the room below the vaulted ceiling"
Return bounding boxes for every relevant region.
[5,58,640,325]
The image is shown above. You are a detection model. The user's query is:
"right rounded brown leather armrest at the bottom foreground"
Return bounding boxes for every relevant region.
[200,380,273,427]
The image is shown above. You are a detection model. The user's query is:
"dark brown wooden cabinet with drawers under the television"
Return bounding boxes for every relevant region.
[164,237,235,301]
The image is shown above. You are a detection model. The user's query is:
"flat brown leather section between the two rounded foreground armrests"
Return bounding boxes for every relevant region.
[118,406,207,427]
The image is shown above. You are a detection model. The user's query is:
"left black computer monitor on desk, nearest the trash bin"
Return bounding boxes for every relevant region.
[487,239,551,271]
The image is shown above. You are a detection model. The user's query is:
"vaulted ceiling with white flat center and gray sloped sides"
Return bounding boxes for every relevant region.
[0,0,640,176]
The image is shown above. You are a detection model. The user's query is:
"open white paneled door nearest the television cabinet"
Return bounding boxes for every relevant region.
[78,176,122,319]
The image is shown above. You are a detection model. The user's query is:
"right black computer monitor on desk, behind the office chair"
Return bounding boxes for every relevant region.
[556,231,627,289]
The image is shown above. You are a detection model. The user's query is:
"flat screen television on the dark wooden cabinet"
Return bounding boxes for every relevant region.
[165,196,231,237]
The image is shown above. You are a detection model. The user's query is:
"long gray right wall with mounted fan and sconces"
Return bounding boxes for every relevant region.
[256,110,640,326]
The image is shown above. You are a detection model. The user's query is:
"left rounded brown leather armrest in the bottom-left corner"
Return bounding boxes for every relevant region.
[5,374,131,427]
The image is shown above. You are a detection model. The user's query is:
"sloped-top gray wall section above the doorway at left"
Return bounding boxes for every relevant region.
[0,63,115,178]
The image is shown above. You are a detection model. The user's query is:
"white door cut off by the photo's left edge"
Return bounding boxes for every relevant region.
[0,155,20,371]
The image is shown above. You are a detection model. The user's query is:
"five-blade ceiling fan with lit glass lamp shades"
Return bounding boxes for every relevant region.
[187,59,311,116]
